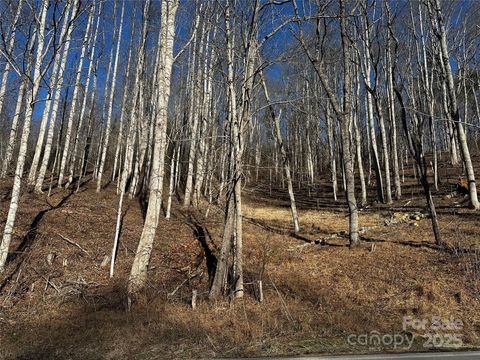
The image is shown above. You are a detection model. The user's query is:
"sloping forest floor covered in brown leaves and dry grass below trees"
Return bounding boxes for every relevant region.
[0,157,480,359]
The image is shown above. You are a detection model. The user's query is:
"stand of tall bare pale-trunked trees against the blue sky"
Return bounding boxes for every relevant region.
[0,0,480,299]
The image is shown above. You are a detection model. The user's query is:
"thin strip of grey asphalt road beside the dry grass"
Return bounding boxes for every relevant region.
[244,351,480,360]
